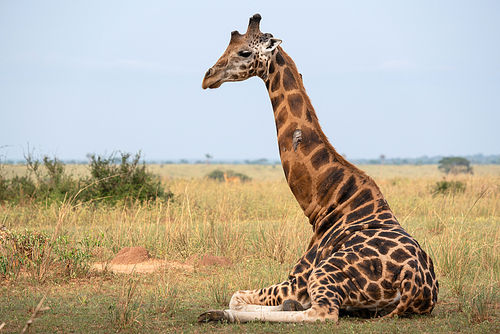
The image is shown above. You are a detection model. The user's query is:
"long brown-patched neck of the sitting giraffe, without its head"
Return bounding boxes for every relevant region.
[264,47,385,230]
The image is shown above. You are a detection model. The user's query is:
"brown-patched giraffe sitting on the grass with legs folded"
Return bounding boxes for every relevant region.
[198,14,439,322]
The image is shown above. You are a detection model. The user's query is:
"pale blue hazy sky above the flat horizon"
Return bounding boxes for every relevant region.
[0,0,500,160]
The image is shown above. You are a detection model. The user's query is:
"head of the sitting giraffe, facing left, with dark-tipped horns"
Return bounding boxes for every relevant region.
[202,14,281,89]
